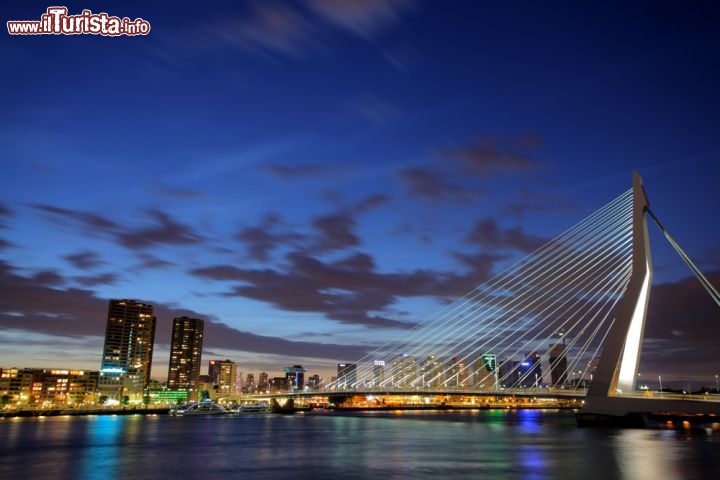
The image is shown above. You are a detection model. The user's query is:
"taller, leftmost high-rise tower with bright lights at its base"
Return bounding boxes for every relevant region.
[98,300,156,403]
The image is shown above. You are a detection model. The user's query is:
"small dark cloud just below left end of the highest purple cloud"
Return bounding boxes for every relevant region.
[400,167,487,203]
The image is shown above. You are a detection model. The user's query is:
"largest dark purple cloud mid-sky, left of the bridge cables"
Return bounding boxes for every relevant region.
[190,246,501,328]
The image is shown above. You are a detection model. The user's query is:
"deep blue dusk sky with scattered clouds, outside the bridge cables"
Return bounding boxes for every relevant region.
[0,0,720,386]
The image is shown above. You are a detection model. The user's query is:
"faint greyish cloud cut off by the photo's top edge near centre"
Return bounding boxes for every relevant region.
[307,0,414,38]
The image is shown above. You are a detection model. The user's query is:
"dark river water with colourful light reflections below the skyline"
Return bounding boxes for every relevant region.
[0,410,720,480]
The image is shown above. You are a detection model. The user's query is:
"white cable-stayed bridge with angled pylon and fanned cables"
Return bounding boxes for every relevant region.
[316,173,720,424]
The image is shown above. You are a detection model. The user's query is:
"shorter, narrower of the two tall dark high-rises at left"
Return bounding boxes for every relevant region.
[167,317,205,401]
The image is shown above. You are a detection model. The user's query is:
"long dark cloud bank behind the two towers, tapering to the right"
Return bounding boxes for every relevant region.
[0,260,367,366]
